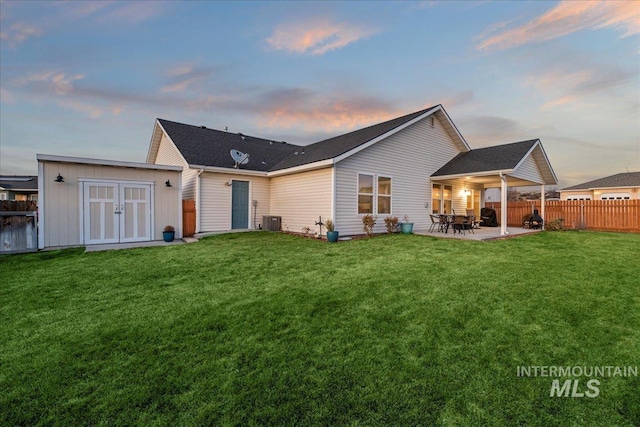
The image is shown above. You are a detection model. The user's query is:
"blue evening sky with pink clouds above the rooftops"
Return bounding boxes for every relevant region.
[0,1,640,187]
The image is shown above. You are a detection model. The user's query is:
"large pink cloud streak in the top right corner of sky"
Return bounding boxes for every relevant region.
[477,0,640,50]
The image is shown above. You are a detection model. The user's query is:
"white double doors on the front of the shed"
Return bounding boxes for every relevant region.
[83,182,151,244]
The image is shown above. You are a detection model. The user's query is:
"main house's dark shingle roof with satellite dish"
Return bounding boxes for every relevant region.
[158,106,438,172]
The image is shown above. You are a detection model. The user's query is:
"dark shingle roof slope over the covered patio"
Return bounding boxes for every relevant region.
[431,139,538,176]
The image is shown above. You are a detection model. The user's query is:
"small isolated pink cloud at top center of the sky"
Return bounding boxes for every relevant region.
[266,19,375,55]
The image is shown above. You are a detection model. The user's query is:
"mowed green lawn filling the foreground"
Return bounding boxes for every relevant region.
[0,232,640,426]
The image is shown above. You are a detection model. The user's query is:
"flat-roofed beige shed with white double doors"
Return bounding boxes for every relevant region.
[37,154,182,249]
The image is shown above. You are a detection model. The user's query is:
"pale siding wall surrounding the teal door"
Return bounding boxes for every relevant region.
[196,172,269,233]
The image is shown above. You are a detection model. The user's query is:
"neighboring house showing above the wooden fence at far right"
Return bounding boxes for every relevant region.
[559,172,640,200]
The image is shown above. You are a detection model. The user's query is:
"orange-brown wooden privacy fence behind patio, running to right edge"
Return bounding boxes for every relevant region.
[487,200,640,232]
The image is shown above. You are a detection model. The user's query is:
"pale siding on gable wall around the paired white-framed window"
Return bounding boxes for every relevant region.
[335,117,466,235]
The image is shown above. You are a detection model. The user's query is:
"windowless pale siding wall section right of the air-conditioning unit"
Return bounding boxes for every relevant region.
[270,168,333,233]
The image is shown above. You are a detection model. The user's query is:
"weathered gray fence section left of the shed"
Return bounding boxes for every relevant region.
[0,200,38,254]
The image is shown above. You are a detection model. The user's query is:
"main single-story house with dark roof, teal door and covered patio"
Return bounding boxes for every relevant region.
[147,105,557,235]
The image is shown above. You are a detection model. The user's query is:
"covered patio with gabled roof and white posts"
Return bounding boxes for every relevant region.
[428,139,558,240]
